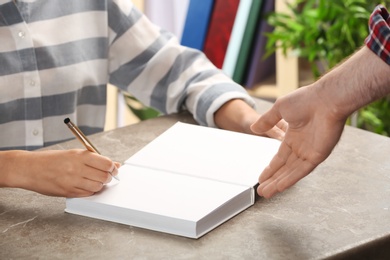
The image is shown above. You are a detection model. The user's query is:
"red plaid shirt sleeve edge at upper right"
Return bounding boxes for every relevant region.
[365,5,390,65]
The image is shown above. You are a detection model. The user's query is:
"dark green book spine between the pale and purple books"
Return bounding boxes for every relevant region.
[233,0,263,84]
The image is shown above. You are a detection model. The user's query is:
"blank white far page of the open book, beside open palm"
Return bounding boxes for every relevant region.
[125,122,280,187]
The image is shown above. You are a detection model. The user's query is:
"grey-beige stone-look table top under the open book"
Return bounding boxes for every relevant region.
[0,100,390,259]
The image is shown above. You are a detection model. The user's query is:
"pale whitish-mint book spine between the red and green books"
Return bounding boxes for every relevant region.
[222,0,254,77]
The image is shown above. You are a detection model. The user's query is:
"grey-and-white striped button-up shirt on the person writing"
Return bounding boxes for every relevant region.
[0,0,254,150]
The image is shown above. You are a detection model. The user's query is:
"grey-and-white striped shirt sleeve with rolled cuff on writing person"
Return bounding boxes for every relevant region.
[109,0,255,127]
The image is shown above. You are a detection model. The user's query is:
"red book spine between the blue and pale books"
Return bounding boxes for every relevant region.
[203,0,240,69]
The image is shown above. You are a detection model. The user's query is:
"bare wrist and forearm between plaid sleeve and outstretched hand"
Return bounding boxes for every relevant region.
[313,47,390,120]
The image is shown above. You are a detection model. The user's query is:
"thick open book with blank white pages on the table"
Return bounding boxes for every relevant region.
[65,122,280,238]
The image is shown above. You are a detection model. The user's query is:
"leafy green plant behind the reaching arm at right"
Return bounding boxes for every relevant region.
[266,0,390,135]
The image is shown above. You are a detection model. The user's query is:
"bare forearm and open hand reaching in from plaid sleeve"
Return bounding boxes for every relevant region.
[252,47,390,198]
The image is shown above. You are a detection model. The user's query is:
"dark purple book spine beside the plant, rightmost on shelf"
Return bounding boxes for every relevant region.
[244,0,275,88]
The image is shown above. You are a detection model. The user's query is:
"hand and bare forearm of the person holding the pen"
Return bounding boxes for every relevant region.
[0,150,120,197]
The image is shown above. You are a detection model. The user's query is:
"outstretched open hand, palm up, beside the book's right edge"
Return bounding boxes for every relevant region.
[251,87,346,198]
